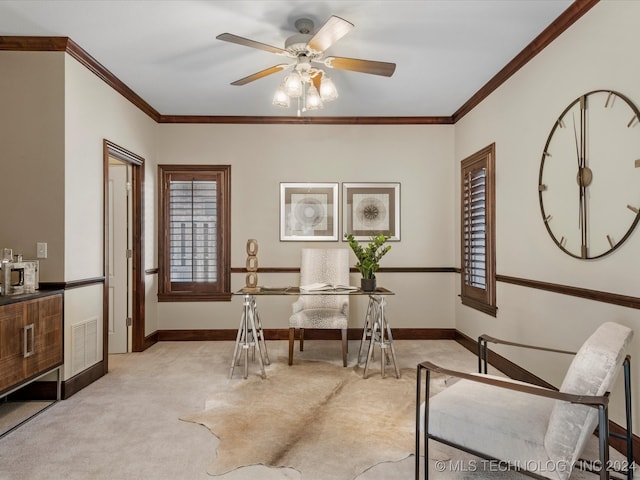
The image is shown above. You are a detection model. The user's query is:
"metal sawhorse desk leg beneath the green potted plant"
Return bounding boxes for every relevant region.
[358,295,400,378]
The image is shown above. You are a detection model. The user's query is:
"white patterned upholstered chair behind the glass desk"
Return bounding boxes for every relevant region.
[289,248,349,367]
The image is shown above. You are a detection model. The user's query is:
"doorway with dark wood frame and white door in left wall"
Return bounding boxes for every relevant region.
[103,140,148,373]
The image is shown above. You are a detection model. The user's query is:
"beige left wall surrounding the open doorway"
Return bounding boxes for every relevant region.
[64,55,157,358]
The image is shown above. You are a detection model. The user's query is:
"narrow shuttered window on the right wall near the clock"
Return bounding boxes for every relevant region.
[460,144,497,316]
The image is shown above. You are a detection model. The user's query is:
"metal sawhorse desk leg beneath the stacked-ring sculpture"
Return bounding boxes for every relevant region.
[229,294,269,378]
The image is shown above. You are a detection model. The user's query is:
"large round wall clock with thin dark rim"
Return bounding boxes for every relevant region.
[538,90,640,259]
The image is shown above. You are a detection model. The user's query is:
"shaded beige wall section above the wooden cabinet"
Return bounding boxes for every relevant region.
[0,52,65,282]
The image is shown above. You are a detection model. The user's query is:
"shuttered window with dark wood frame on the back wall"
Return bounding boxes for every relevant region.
[158,165,231,301]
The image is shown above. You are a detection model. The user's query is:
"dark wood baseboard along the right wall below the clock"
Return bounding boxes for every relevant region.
[455,331,640,464]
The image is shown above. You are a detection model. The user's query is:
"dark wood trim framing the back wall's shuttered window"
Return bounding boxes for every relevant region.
[158,165,231,302]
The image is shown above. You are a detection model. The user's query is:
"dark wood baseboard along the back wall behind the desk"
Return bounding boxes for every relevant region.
[155,328,456,342]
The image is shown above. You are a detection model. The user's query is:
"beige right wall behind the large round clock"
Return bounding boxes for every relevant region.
[455,1,640,431]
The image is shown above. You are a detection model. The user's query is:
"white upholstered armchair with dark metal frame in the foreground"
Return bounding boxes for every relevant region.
[415,322,633,480]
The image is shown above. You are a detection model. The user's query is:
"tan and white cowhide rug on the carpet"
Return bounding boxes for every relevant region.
[182,359,444,480]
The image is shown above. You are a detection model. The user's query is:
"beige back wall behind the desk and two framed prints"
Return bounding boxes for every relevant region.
[157,124,455,329]
